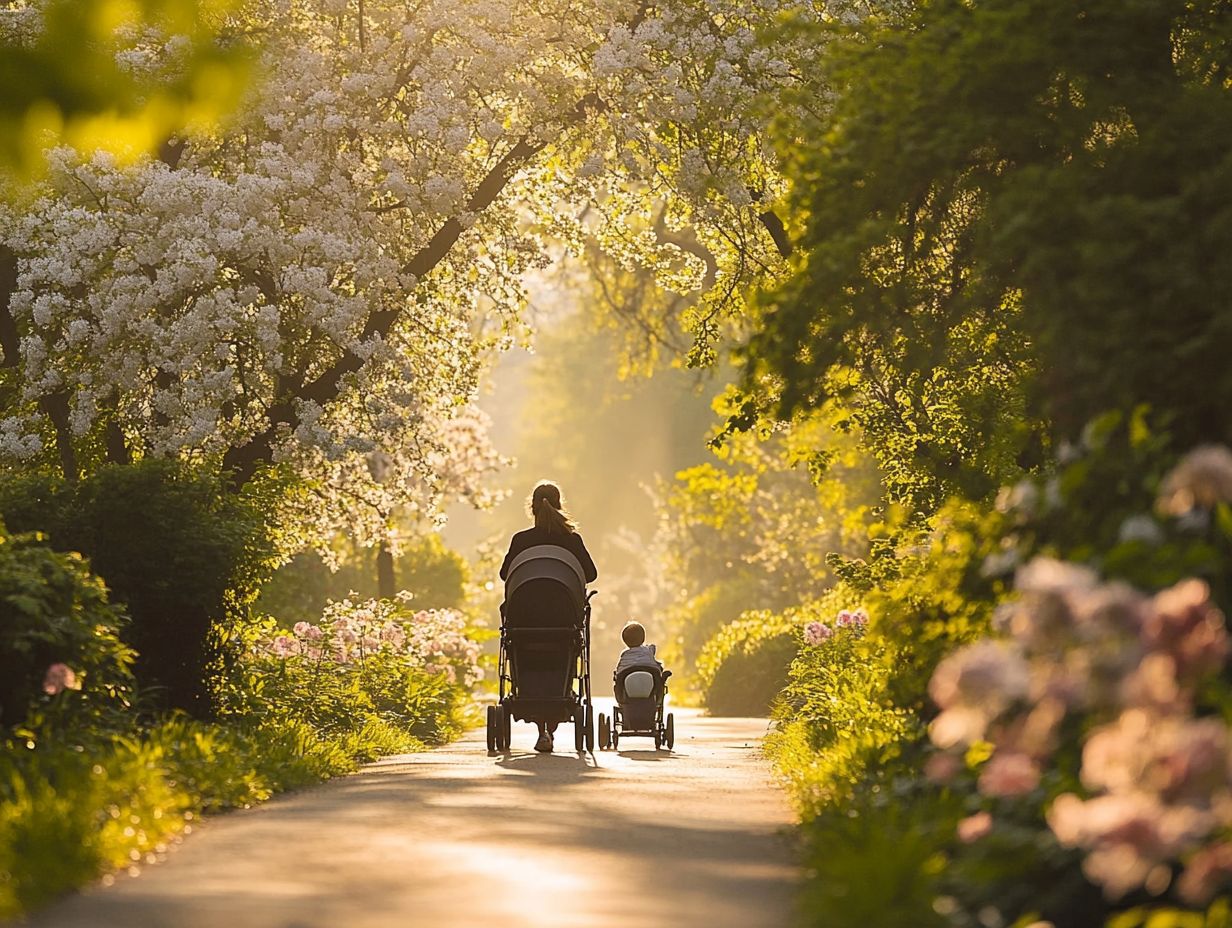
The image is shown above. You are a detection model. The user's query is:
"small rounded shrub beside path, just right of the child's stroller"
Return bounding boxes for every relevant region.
[697,611,798,716]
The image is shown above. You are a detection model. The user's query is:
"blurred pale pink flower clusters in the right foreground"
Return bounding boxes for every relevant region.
[930,558,1232,905]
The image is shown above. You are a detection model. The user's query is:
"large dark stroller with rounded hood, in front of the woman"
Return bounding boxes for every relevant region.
[488,545,595,751]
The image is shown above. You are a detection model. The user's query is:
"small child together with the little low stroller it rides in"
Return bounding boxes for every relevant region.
[599,622,676,751]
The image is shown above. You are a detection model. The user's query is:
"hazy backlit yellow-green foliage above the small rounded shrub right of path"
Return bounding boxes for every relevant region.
[655,404,880,669]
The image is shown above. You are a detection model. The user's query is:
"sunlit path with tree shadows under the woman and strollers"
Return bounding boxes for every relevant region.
[34,701,796,928]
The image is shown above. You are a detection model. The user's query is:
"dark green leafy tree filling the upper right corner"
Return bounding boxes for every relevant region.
[748,0,1232,504]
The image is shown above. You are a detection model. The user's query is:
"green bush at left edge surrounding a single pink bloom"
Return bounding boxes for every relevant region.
[0,526,133,730]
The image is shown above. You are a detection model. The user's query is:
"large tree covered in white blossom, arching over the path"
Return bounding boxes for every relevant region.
[0,0,827,542]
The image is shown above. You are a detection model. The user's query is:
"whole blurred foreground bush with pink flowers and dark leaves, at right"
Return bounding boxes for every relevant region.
[896,436,1232,926]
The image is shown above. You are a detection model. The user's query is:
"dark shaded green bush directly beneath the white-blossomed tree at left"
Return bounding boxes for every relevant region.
[0,460,276,717]
